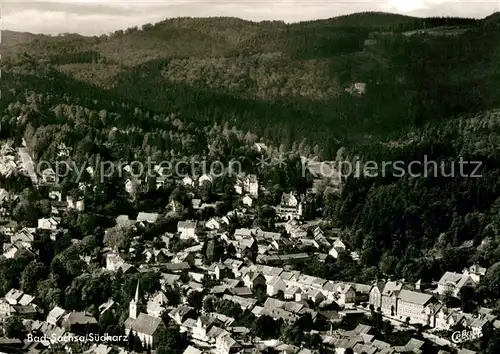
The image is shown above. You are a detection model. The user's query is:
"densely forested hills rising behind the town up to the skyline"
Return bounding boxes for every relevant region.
[2,13,498,158]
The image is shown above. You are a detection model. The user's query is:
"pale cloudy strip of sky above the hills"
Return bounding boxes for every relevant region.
[0,0,500,35]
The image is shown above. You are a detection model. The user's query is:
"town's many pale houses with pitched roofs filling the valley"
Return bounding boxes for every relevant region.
[0,142,494,354]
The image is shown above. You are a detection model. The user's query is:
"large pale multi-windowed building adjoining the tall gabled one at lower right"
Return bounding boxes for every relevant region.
[396,289,440,327]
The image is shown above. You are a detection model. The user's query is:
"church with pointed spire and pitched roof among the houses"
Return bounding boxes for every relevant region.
[125,282,165,349]
